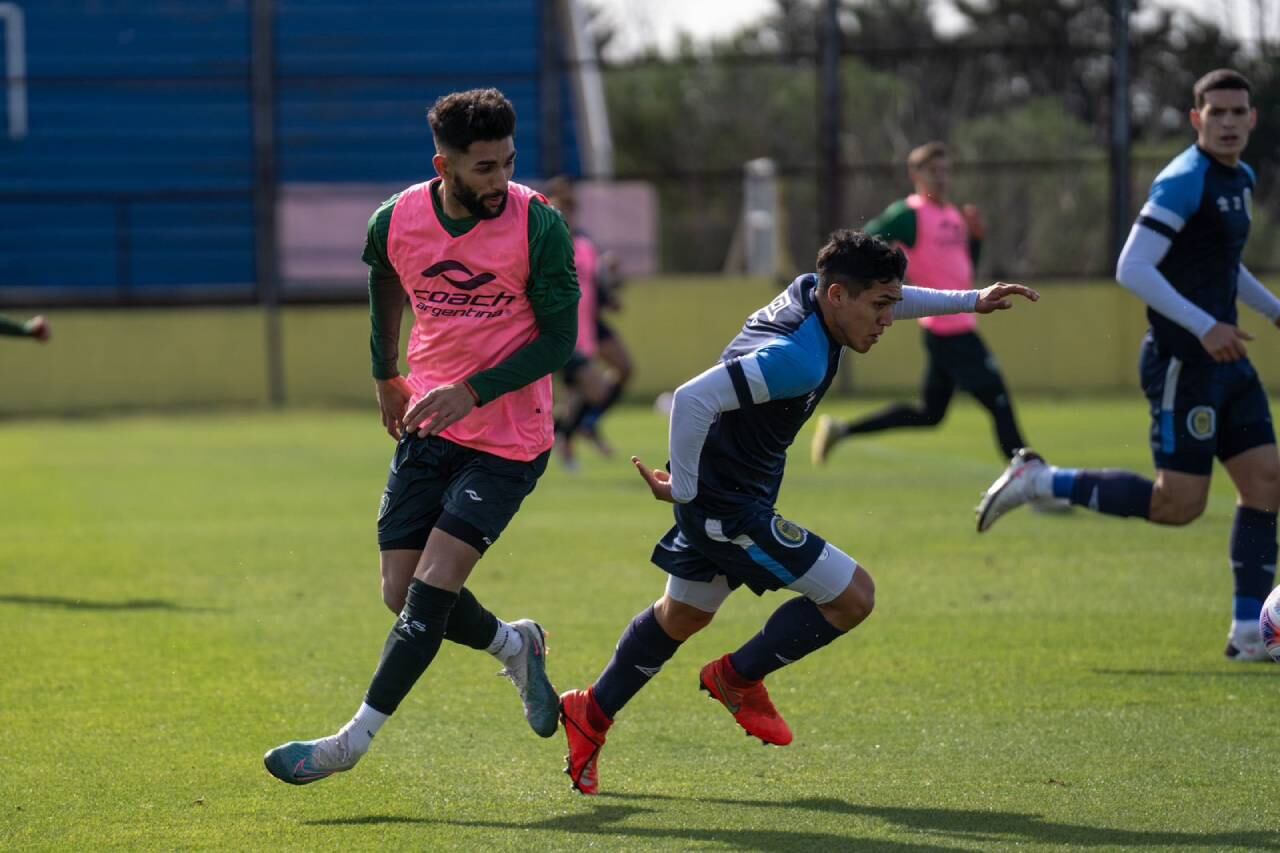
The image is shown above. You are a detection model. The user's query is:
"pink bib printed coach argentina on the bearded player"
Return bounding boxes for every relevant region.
[387,178,554,461]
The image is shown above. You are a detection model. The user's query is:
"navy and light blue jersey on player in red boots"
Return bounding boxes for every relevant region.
[694,273,842,517]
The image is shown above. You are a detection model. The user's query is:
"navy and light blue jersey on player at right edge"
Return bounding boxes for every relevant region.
[1138,145,1254,361]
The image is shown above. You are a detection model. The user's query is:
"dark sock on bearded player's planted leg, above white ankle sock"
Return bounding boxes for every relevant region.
[365,578,458,715]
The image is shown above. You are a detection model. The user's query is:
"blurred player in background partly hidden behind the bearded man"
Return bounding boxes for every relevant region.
[544,175,631,469]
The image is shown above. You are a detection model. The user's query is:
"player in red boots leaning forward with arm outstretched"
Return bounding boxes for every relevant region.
[561,231,1038,794]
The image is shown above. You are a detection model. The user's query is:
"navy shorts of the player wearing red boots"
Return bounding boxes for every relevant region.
[653,503,827,596]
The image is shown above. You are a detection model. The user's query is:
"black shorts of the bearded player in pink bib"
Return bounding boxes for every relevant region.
[378,433,550,553]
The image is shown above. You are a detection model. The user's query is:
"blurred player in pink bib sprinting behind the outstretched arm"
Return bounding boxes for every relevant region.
[812,142,1025,465]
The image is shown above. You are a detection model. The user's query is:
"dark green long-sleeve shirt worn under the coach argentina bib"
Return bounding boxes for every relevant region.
[364,184,580,406]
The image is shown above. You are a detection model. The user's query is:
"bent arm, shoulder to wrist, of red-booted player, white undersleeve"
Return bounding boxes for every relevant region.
[665,338,827,503]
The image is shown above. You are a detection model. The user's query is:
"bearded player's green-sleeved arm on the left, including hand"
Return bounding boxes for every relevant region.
[361,193,413,439]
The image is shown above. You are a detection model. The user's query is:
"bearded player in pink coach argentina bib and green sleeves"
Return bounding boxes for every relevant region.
[264,88,579,785]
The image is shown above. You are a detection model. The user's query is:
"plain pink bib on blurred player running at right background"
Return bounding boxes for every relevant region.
[902,193,978,336]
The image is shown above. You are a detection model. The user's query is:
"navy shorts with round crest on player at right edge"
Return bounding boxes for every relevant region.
[1142,338,1276,475]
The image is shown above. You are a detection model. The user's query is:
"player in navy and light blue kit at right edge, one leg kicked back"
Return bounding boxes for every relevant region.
[978,69,1280,661]
